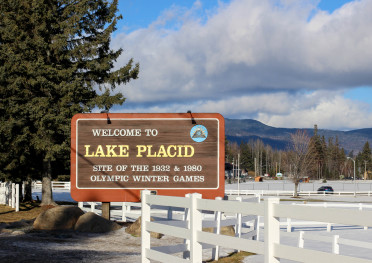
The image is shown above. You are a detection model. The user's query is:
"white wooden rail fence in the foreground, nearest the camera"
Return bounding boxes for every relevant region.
[141,191,372,263]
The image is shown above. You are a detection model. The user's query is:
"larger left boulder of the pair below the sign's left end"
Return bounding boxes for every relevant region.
[33,206,84,230]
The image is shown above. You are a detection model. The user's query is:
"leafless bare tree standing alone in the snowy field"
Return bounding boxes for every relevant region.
[283,130,315,196]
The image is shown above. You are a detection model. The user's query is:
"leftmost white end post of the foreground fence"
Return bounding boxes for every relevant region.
[141,190,151,263]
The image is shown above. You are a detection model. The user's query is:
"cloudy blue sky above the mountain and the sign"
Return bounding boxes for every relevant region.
[112,0,372,130]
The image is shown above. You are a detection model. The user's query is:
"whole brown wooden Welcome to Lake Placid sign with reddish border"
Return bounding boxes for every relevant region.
[71,113,225,202]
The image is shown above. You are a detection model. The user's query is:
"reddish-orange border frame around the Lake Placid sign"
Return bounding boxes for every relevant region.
[71,113,225,202]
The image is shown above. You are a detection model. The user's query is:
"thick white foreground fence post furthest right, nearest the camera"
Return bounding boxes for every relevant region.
[264,198,280,263]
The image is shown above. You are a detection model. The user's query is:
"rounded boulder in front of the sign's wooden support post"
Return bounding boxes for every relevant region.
[75,212,121,233]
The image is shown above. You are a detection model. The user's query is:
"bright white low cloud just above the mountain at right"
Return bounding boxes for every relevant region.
[257,91,372,130]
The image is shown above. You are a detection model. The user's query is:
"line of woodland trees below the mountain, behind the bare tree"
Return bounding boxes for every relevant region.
[226,131,372,180]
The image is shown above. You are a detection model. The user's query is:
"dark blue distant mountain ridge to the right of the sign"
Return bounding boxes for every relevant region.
[225,119,372,153]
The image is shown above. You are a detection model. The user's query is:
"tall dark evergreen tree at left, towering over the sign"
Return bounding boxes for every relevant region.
[0,0,139,204]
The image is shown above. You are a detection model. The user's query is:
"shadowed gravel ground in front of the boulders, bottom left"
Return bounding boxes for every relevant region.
[0,222,237,263]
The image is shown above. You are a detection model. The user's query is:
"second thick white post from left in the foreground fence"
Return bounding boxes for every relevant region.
[190,193,203,263]
